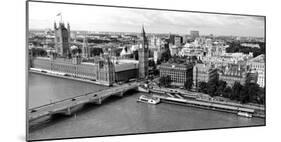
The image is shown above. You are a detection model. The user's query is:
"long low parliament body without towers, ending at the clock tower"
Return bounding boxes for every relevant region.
[29,55,138,85]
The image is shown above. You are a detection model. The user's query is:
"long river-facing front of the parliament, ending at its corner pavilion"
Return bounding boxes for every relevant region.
[31,56,115,85]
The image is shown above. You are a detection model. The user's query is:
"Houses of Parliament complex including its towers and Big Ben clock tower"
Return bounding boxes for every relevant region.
[29,22,148,86]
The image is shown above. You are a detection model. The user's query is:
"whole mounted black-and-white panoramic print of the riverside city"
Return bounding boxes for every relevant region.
[27,2,266,140]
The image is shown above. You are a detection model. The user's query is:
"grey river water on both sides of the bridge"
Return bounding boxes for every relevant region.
[28,73,265,140]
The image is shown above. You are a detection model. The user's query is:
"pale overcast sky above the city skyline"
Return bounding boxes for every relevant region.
[29,2,264,37]
